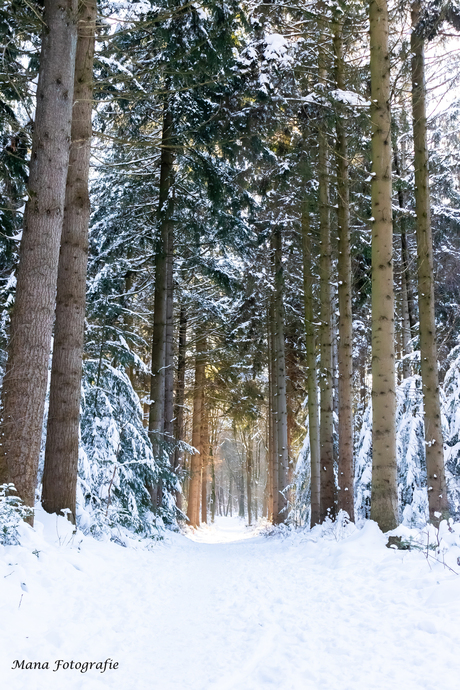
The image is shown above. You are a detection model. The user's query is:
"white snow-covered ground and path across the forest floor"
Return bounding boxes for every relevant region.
[0,513,460,690]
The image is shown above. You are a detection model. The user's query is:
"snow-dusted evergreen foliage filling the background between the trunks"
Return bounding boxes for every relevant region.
[0,0,460,540]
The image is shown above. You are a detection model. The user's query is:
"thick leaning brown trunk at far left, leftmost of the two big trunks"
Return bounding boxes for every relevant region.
[0,0,77,506]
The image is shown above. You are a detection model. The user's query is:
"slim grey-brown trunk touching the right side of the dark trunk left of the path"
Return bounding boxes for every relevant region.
[164,225,174,441]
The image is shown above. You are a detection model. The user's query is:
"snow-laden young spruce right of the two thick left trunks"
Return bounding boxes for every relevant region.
[77,360,177,537]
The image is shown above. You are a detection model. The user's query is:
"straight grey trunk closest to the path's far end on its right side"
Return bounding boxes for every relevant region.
[273,230,289,524]
